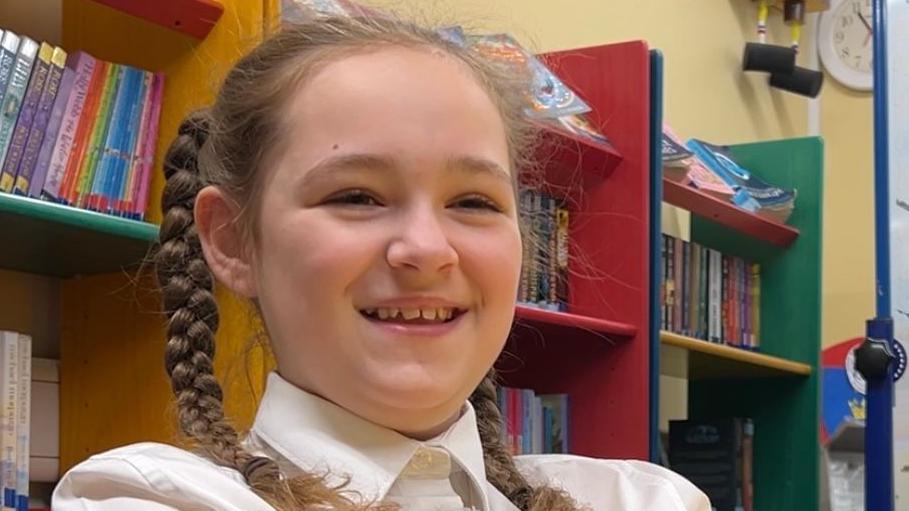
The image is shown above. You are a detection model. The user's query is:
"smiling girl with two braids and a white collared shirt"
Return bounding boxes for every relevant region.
[53,10,710,511]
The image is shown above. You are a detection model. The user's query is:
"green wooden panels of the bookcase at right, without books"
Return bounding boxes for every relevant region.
[688,137,824,511]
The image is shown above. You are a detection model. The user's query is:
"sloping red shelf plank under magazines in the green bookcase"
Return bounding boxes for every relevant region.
[663,177,799,247]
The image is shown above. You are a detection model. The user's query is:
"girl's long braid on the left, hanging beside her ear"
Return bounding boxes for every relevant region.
[156,112,274,480]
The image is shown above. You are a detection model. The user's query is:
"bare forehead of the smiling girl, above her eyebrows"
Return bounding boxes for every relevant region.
[286,47,508,172]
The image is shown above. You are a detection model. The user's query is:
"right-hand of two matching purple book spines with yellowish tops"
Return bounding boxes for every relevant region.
[13,46,66,195]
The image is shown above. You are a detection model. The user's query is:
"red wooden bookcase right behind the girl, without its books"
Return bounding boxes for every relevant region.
[496,41,651,459]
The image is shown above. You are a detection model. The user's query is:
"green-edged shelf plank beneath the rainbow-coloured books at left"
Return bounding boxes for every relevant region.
[0,193,158,277]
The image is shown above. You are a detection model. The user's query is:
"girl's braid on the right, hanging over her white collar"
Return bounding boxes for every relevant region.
[470,369,580,511]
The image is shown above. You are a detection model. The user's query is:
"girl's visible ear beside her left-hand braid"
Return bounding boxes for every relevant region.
[193,186,258,298]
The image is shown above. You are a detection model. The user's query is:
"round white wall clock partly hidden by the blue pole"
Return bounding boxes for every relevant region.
[818,0,874,91]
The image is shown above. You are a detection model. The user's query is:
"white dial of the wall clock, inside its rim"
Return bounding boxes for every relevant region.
[833,0,874,73]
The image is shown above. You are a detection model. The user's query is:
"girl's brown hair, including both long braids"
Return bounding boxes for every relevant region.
[156,12,577,511]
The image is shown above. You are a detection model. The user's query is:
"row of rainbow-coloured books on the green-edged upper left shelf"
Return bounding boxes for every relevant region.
[0,30,164,220]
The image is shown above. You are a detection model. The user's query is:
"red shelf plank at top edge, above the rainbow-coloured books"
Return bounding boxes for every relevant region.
[92,0,224,40]
